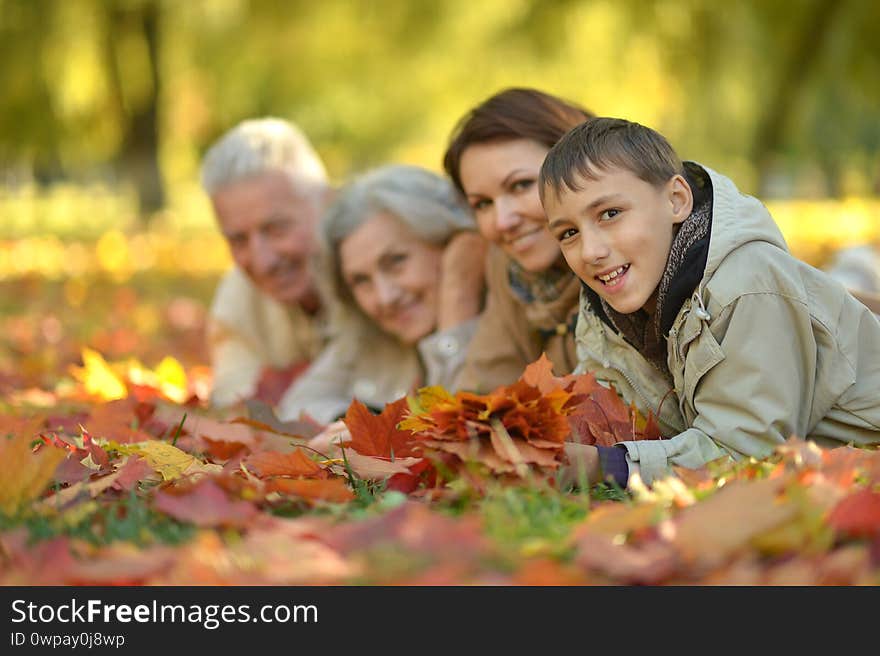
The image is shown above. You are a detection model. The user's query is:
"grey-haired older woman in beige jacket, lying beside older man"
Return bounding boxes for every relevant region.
[278,165,485,423]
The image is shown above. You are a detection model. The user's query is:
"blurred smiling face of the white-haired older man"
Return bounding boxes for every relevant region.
[211,171,319,305]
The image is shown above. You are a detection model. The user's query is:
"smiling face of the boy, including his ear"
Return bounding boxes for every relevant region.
[544,168,693,314]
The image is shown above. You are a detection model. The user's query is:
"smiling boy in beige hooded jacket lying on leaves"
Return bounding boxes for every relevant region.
[539,118,880,484]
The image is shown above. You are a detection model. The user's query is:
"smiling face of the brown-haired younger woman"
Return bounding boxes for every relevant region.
[459,139,561,273]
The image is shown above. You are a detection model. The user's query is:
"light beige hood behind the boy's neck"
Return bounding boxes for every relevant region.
[685,162,788,279]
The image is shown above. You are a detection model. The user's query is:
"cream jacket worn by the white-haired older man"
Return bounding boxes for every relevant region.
[207,267,323,407]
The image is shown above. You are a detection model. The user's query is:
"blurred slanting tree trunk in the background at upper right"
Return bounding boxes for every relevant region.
[752,0,845,195]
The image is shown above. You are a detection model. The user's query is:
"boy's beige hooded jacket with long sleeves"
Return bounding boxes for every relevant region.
[577,162,880,483]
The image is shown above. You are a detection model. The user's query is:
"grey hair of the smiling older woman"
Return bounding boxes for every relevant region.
[319,164,476,326]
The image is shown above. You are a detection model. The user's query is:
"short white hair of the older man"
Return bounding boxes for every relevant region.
[202,117,327,195]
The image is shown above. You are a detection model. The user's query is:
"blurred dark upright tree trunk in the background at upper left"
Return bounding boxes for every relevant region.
[105,0,165,223]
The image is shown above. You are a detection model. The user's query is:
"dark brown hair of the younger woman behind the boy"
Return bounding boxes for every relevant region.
[443,87,593,193]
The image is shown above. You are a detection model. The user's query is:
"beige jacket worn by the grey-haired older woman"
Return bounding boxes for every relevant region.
[277,319,477,424]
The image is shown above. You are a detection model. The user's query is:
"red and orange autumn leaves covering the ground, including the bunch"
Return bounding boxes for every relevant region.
[0,358,880,585]
